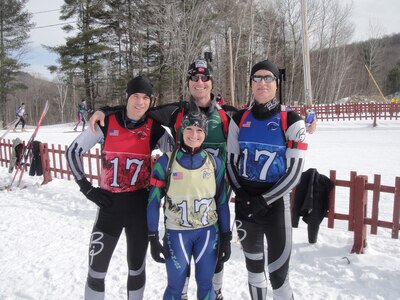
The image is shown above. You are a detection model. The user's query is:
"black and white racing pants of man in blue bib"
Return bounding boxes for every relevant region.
[236,197,293,300]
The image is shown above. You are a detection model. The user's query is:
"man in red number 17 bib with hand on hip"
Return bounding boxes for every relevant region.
[66,76,170,300]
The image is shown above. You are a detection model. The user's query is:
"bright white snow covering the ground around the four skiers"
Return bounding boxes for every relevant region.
[0,121,400,300]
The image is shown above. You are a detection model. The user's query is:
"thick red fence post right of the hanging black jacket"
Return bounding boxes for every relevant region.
[351,176,368,254]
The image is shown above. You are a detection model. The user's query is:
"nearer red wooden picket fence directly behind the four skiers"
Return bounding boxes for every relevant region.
[0,140,400,253]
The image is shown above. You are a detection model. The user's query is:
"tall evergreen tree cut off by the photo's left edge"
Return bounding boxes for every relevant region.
[0,0,34,123]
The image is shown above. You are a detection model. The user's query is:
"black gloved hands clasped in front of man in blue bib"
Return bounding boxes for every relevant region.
[235,191,270,218]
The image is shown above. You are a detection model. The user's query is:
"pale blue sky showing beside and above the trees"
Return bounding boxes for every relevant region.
[26,0,400,79]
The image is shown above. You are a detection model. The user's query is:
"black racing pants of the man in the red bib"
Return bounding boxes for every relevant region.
[85,190,148,300]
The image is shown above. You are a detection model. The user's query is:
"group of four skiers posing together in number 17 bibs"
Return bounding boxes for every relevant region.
[66,59,307,300]
